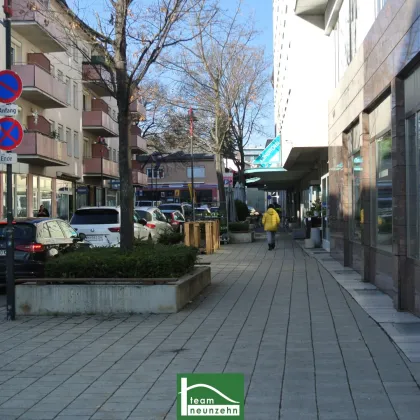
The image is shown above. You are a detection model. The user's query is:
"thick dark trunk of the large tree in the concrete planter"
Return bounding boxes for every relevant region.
[118,109,134,250]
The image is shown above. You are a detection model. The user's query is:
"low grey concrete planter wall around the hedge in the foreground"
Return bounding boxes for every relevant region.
[16,266,211,315]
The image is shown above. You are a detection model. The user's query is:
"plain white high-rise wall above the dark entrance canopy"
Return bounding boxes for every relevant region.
[273,0,334,164]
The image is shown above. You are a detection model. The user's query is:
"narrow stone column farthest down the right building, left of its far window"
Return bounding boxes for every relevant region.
[341,133,353,267]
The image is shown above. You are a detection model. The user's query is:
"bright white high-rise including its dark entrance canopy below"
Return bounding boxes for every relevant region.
[273,0,334,225]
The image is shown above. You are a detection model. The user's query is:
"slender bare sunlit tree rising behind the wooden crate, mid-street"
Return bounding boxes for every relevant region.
[169,2,255,207]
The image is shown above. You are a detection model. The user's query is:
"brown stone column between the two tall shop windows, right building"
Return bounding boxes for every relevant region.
[359,113,375,282]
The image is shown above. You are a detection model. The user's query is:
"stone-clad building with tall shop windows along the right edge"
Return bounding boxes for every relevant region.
[295,0,420,313]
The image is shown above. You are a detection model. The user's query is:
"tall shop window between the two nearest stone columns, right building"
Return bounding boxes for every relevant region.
[373,132,392,252]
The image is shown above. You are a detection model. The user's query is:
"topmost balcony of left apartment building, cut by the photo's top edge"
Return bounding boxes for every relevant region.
[12,0,67,53]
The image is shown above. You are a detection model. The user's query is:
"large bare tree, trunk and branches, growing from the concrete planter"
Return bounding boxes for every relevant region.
[35,0,216,250]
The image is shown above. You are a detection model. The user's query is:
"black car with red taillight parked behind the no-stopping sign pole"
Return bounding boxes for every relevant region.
[0,217,91,284]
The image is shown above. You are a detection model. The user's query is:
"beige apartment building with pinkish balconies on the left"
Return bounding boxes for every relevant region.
[0,0,147,220]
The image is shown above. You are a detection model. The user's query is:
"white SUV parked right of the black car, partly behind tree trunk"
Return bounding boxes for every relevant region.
[70,207,152,247]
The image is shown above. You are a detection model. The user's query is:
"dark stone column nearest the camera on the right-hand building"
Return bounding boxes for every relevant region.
[391,78,415,310]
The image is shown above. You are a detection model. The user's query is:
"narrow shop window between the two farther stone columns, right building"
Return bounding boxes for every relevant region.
[347,125,364,242]
